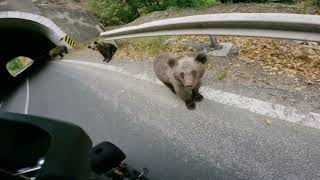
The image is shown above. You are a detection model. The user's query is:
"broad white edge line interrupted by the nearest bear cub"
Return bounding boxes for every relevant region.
[63,60,320,129]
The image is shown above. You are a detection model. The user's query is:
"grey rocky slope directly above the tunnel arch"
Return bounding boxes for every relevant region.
[0,0,103,43]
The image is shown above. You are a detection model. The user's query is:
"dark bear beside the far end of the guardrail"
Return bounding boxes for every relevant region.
[88,41,118,62]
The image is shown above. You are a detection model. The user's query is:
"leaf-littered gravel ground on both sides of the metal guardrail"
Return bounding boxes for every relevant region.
[67,3,320,113]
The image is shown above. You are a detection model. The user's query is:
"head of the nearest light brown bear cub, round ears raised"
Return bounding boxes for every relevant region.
[168,53,207,89]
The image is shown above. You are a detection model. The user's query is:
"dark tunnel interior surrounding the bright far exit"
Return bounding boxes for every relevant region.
[0,18,60,101]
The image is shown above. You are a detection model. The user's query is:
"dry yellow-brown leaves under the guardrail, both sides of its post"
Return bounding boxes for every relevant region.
[116,36,320,85]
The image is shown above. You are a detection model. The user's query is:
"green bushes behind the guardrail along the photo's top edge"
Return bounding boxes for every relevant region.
[90,0,320,26]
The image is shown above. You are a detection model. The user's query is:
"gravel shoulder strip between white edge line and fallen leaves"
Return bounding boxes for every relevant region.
[65,45,320,113]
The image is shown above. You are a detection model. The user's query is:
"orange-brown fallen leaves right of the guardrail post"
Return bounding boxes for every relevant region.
[220,37,320,84]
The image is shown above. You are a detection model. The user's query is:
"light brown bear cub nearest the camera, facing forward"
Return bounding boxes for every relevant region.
[153,53,207,110]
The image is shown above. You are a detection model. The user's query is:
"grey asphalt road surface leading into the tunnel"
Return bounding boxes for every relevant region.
[2,62,320,180]
